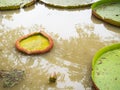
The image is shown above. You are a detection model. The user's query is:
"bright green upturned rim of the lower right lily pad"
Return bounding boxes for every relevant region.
[91,43,120,90]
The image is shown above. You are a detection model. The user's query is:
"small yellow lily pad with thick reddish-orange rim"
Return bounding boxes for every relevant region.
[16,31,53,54]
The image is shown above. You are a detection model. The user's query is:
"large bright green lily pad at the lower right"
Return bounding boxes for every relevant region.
[92,43,120,90]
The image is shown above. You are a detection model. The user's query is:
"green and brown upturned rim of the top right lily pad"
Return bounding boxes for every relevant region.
[91,0,120,27]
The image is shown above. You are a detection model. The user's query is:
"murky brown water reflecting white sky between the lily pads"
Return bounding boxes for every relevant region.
[0,4,120,90]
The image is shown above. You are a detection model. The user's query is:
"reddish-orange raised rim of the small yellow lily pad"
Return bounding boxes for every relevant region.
[15,31,54,55]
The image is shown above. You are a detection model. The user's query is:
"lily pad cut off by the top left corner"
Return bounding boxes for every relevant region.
[0,0,35,10]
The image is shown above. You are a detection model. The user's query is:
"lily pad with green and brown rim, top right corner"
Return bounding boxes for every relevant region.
[92,0,120,26]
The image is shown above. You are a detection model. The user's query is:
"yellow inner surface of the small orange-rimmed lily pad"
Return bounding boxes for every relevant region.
[20,34,49,51]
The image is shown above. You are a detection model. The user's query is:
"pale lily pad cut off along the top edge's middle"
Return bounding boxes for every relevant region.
[39,0,98,8]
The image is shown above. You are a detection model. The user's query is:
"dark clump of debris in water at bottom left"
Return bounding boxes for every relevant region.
[0,69,25,88]
